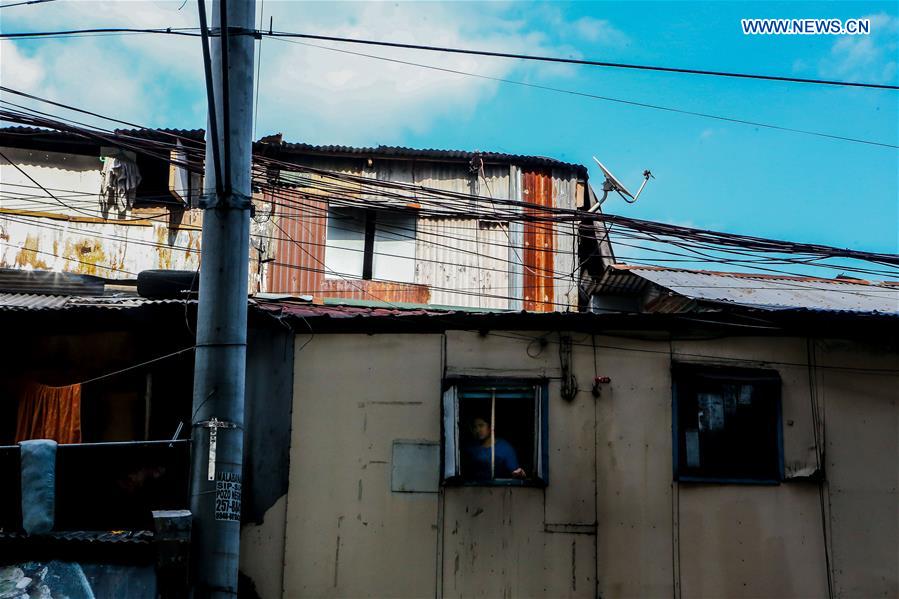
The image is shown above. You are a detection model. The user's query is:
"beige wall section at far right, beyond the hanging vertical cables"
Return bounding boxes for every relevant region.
[816,341,899,597]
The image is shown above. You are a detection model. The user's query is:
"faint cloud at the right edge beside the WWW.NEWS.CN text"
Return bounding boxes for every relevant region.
[819,13,899,83]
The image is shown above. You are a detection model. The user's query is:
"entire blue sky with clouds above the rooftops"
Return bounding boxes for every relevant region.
[0,0,899,264]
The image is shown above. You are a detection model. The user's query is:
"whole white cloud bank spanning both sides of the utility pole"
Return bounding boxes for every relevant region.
[2,0,626,144]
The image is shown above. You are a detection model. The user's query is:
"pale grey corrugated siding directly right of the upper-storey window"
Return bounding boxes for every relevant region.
[415,218,509,309]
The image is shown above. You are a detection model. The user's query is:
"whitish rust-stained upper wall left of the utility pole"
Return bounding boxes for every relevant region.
[0,148,200,278]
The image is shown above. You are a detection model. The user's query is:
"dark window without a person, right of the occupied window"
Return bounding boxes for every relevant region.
[673,365,783,483]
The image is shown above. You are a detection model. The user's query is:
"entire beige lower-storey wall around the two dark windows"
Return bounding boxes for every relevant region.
[253,332,899,597]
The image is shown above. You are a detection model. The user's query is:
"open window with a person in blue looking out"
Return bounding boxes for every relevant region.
[443,378,549,485]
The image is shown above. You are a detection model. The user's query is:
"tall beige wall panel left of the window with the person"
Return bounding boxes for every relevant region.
[284,335,442,597]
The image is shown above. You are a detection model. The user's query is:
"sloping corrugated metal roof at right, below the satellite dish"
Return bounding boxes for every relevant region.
[610,265,899,316]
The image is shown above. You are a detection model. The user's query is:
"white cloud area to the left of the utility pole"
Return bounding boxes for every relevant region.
[0,2,203,128]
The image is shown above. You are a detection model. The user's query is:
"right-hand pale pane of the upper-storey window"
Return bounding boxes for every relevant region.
[372,212,417,283]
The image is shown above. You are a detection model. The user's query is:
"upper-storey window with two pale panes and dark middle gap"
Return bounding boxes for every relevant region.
[325,207,417,283]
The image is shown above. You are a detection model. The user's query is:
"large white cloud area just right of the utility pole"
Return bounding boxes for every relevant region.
[253,3,616,144]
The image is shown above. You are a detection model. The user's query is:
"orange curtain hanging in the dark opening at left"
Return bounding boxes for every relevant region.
[16,383,81,443]
